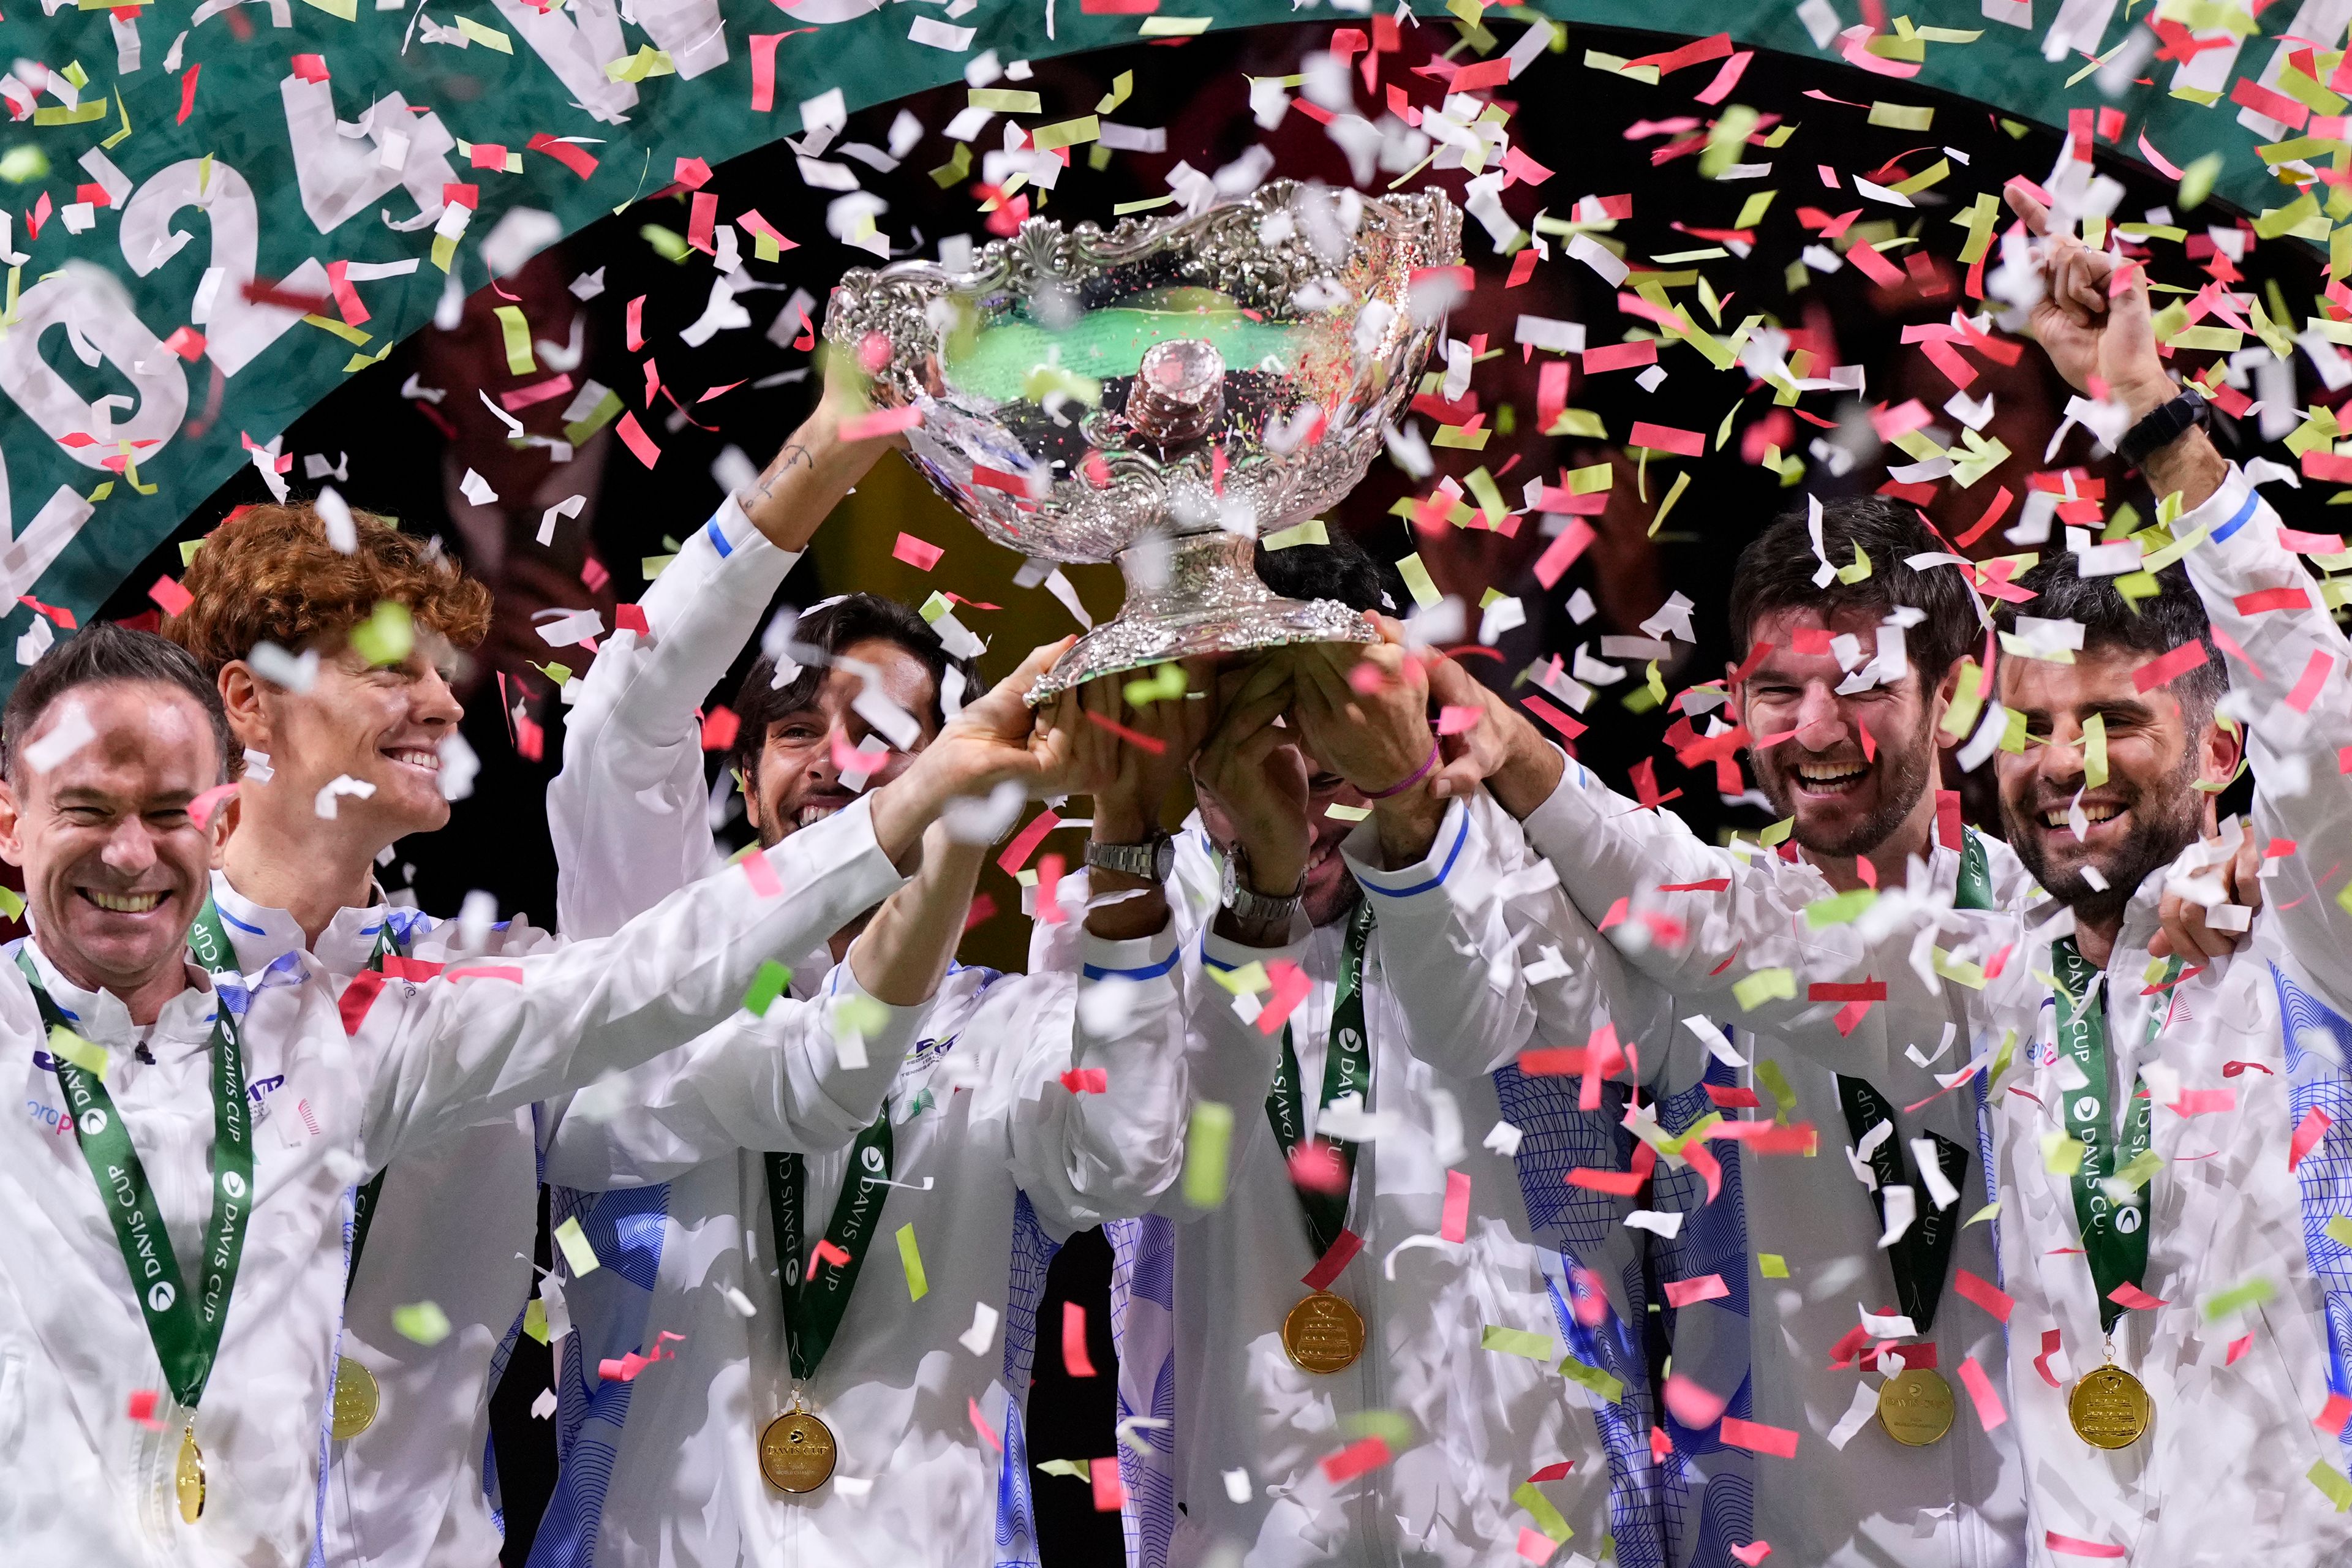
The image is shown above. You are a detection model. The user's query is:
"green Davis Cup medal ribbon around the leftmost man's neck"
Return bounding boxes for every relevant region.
[17,898,254,1411]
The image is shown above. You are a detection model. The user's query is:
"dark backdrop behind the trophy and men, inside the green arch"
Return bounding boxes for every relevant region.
[59,21,2340,1563]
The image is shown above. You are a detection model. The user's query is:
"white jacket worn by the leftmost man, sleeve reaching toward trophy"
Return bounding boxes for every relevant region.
[0,804,903,1568]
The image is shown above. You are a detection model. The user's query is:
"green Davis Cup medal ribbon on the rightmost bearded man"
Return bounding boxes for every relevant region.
[2051,936,2180,1333]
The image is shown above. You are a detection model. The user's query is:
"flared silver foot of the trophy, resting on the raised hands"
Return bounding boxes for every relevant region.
[1028,533,1374,707]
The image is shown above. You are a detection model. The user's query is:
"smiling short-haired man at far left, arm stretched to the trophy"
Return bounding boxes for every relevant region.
[0,628,1075,1568]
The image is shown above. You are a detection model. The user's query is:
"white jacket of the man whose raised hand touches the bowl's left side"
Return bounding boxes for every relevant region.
[532,503,1188,1568]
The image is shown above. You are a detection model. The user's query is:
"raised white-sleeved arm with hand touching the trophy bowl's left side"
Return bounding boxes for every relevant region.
[548,379,889,938]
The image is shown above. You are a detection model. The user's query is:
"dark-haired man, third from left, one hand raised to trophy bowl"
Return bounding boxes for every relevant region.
[532,374,1212,1568]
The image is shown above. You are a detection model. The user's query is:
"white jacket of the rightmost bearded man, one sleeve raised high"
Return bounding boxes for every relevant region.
[1514,470,2352,1568]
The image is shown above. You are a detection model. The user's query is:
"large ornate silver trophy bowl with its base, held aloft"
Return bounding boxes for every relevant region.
[826,181,1461,703]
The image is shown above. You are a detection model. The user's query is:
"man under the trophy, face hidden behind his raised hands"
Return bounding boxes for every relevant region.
[1112,531,1670,1568]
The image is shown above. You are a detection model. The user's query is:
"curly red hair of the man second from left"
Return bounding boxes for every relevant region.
[162,501,489,675]
